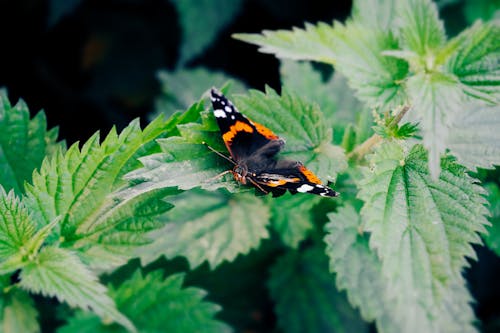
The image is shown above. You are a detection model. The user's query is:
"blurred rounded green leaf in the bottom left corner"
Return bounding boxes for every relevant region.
[0,276,40,333]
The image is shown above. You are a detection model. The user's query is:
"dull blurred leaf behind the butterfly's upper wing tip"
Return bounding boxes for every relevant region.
[156,67,245,115]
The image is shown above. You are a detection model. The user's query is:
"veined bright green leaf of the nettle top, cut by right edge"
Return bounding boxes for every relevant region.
[445,21,500,103]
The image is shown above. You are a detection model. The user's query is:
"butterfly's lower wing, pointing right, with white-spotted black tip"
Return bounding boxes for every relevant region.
[252,160,339,197]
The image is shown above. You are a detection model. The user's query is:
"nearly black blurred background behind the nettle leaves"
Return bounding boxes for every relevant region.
[0,0,500,332]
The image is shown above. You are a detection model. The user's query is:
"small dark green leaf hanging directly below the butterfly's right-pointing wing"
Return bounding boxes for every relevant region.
[270,193,321,248]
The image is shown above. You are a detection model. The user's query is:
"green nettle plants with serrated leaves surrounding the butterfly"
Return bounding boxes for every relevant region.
[0,0,500,332]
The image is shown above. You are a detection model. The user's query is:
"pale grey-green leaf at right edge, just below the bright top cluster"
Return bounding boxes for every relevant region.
[445,103,500,171]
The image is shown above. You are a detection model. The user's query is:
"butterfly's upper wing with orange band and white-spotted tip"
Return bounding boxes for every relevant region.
[211,88,284,160]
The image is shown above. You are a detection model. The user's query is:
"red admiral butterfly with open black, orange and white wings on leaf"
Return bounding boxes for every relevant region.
[211,89,338,197]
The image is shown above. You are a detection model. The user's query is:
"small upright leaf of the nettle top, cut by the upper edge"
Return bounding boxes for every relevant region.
[397,0,446,56]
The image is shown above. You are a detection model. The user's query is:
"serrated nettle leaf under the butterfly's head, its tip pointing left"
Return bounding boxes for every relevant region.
[119,102,238,196]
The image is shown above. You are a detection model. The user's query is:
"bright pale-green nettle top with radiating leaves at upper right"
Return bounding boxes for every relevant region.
[235,0,500,178]
